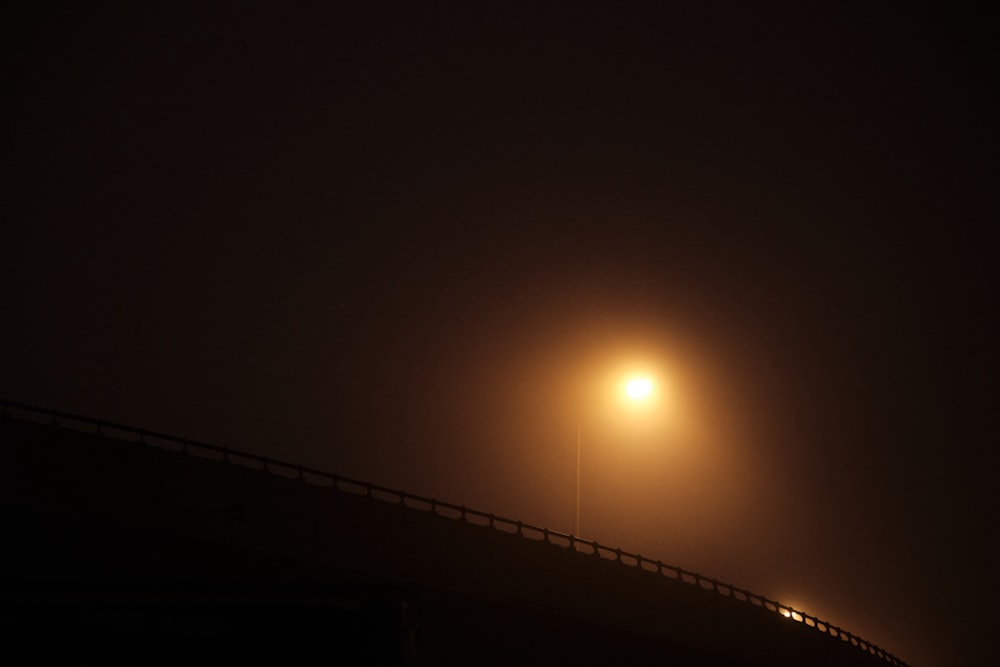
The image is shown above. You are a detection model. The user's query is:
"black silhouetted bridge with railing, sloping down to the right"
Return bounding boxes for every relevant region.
[0,401,905,666]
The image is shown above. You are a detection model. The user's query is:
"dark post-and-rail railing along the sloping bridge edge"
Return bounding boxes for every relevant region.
[0,400,908,667]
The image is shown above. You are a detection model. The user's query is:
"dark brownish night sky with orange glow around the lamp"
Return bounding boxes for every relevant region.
[0,2,1000,667]
